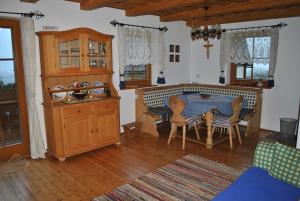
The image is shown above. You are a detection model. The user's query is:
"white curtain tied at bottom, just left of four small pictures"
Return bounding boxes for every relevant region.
[151,30,166,84]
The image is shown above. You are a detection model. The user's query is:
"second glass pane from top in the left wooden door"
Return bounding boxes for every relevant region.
[0,61,15,88]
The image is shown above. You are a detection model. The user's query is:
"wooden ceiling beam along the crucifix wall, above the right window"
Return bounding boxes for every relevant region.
[186,6,300,27]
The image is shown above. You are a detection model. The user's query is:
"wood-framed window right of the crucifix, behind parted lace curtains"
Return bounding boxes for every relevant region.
[230,37,271,87]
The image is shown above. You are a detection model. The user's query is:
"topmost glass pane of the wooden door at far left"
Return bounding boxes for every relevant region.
[0,27,13,59]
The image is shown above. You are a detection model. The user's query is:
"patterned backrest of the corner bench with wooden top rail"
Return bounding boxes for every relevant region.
[142,84,261,109]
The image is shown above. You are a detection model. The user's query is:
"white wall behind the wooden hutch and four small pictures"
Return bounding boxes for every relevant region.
[0,0,190,138]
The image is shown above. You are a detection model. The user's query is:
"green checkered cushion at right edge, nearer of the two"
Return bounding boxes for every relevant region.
[269,143,300,187]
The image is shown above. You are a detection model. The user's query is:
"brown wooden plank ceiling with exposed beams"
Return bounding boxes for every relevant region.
[22,0,300,26]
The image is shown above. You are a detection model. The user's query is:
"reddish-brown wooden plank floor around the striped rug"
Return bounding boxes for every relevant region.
[0,122,269,201]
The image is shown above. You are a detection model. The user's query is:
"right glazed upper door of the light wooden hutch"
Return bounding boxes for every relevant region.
[88,40,108,69]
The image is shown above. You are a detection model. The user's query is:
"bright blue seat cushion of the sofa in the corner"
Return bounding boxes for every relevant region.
[213,167,300,201]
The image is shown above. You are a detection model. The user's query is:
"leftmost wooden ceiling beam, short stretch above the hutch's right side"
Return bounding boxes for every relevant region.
[80,0,126,10]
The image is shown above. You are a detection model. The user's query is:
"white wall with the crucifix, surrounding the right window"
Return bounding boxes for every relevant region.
[190,17,300,131]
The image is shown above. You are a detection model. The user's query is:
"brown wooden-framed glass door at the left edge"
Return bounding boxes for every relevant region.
[0,19,29,160]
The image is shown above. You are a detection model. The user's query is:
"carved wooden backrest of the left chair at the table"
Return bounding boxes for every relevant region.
[169,96,185,123]
